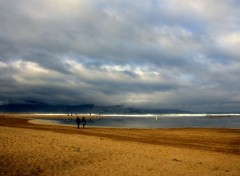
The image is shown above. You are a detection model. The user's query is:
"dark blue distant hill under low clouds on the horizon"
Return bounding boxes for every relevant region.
[0,103,187,114]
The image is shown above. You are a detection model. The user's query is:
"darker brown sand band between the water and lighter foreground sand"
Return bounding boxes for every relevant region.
[0,113,240,155]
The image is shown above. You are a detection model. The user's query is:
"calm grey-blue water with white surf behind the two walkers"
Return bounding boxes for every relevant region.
[36,114,240,128]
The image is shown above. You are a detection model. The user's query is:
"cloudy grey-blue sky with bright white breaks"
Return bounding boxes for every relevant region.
[0,0,240,112]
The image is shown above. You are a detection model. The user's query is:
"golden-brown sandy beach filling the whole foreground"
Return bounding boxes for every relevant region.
[0,115,240,176]
